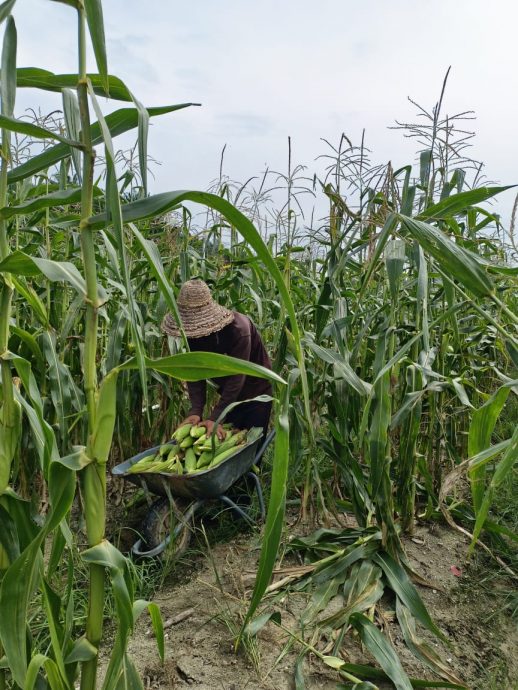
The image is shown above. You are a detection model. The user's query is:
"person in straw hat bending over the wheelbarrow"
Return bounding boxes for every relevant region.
[162,280,272,439]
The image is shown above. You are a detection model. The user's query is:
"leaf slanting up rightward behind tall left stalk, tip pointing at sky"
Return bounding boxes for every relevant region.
[7,102,196,184]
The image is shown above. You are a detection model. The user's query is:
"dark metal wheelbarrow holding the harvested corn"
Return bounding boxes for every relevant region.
[112,427,275,558]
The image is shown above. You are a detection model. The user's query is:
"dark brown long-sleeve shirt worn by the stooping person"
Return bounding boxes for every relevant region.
[187,312,272,421]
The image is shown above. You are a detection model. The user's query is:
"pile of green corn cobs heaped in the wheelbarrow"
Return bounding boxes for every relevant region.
[128,424,247,474]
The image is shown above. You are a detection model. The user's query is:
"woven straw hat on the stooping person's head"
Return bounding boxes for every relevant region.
[162,280,234,338]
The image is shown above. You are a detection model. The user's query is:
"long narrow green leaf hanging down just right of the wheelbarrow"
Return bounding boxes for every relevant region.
[239,386,290,638]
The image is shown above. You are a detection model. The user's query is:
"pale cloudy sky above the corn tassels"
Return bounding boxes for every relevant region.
[8,0,518,230]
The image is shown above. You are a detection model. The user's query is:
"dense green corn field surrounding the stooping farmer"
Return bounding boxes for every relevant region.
[0,0,518,690]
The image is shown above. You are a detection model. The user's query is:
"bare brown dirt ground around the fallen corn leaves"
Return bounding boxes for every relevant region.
[110,500,518,690]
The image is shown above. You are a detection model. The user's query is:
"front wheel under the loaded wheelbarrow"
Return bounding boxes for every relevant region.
[142,498,193,558]
